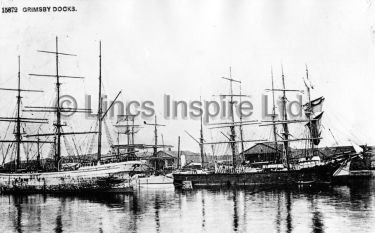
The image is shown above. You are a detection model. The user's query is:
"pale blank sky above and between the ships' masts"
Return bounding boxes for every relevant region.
[0,0,375,158]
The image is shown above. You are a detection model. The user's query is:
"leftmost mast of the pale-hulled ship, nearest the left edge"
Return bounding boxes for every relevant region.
[15,56,22,169]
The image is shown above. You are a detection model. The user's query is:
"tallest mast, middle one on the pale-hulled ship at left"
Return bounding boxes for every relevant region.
[55,36,62,167]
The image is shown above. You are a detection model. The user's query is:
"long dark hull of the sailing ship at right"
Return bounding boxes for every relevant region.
[173,163,340,188]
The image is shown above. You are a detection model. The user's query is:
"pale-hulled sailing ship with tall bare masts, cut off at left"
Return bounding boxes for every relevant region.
[0,37,140,193]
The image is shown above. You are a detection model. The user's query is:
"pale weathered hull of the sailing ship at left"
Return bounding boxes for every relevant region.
[0,162,142,193]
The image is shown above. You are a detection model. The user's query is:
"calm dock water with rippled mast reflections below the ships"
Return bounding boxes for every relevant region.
[0,180,375,232]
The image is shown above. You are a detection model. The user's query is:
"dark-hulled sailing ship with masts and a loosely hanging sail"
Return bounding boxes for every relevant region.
[173,68,358,188]
